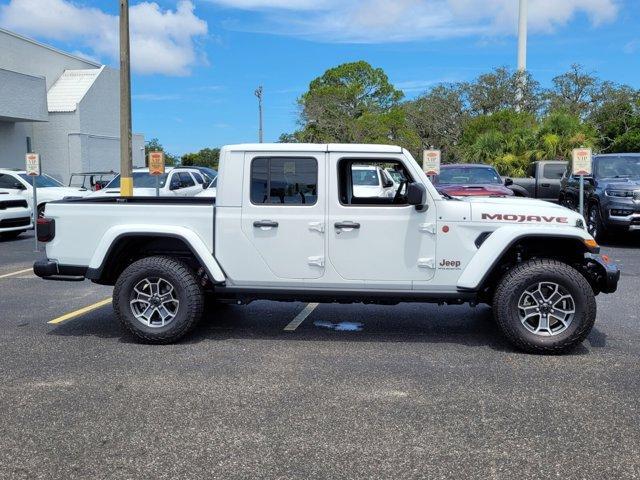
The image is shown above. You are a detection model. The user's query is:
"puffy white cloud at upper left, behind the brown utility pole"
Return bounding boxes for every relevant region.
[0,0,207,75]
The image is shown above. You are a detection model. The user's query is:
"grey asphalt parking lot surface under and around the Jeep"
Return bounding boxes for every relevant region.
[0,231,640,479]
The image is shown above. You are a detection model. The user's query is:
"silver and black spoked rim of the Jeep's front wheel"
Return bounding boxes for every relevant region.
[518,282,576,337]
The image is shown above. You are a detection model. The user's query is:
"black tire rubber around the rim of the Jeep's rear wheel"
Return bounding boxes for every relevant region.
[113,256,204,344]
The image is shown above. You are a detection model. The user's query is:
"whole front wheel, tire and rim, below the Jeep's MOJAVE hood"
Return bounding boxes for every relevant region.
[493,259,596,354]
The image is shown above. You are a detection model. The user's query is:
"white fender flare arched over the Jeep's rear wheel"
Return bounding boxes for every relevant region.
[87,225,226,284]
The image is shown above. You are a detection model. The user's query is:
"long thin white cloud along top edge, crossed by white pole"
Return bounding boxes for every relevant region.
[209,0,622,43]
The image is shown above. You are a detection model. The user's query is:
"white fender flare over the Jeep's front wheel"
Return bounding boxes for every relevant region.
[457,225,593,290]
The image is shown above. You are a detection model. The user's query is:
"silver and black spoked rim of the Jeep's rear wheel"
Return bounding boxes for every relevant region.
[129,277,180,328]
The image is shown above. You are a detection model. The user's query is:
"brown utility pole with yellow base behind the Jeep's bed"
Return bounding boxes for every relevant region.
[120,0,133,197]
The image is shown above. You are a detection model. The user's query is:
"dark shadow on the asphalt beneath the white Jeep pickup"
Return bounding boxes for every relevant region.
[49,301,606,355]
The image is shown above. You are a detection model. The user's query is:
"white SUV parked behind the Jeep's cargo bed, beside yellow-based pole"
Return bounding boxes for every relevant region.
[89,167,204,197]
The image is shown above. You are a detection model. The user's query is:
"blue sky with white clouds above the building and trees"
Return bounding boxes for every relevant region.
[0,0,640,154]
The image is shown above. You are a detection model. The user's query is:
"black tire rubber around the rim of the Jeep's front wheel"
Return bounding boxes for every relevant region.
[493,259,596,354]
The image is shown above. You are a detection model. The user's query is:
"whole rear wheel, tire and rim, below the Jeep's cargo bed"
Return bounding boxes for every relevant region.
[113,257,204,344]
